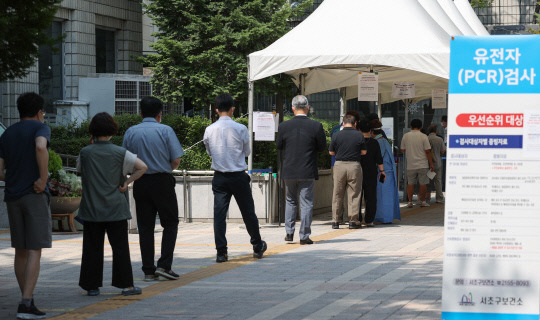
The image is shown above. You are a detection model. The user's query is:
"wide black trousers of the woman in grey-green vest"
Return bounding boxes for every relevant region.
[79,220,133,291]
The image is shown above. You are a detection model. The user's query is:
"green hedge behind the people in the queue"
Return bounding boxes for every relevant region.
[51,114,337,170]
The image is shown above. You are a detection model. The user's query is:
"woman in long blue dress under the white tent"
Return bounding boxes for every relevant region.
[371,119,401,223]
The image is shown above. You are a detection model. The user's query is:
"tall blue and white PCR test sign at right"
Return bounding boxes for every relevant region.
[442,35,540,320]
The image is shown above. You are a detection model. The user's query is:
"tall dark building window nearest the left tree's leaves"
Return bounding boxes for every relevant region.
[38,21,64,113]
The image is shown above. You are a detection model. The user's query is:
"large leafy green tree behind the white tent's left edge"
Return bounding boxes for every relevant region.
[141,0,312,110]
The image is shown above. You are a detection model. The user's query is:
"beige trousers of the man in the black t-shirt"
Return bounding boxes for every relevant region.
[332,161,362,222]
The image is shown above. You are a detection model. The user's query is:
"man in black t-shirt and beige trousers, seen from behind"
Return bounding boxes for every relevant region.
[329,115,366,229]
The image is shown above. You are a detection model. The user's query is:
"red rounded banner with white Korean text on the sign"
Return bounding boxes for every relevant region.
[456,113,523,128]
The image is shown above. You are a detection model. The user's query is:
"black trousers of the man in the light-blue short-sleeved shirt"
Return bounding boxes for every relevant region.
[133,173,178,275]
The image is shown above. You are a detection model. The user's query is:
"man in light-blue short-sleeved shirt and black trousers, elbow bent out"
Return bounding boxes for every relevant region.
[122,97,184,281]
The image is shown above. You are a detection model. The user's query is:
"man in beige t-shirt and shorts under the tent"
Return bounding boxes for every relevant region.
[401,119,435,208]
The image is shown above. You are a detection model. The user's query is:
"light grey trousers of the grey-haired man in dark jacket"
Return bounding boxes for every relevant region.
[283,179,315,240]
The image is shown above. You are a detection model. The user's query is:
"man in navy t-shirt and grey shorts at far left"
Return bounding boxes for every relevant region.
[0,92,52,319]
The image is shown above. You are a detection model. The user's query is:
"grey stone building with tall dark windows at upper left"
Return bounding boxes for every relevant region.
[0,0,143,125]
